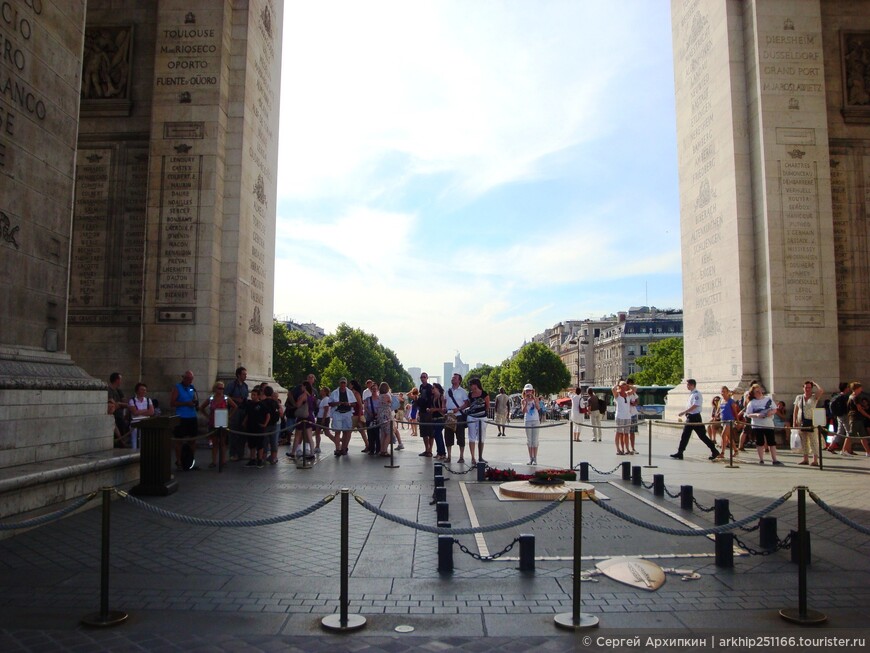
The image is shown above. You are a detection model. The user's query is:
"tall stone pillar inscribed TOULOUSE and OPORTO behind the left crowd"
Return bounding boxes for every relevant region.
[142,0,282,394]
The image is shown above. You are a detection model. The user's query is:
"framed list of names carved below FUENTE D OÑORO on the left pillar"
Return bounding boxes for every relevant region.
[157,154,202,307]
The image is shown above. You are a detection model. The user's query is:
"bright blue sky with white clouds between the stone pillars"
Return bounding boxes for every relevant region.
[275,0,682,374]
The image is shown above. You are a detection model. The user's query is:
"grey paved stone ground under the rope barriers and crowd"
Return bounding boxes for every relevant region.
[0,425,870,652]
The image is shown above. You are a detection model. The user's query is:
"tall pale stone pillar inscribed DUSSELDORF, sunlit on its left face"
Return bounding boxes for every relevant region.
[669,0,839,414]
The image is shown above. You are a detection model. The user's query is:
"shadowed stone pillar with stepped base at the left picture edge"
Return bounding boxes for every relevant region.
[0,0,135,515]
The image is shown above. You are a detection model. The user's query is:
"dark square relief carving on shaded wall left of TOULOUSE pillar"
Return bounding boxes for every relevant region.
[81,25,133,100]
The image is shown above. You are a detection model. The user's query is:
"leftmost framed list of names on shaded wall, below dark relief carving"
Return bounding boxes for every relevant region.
[69,147,114,311]
